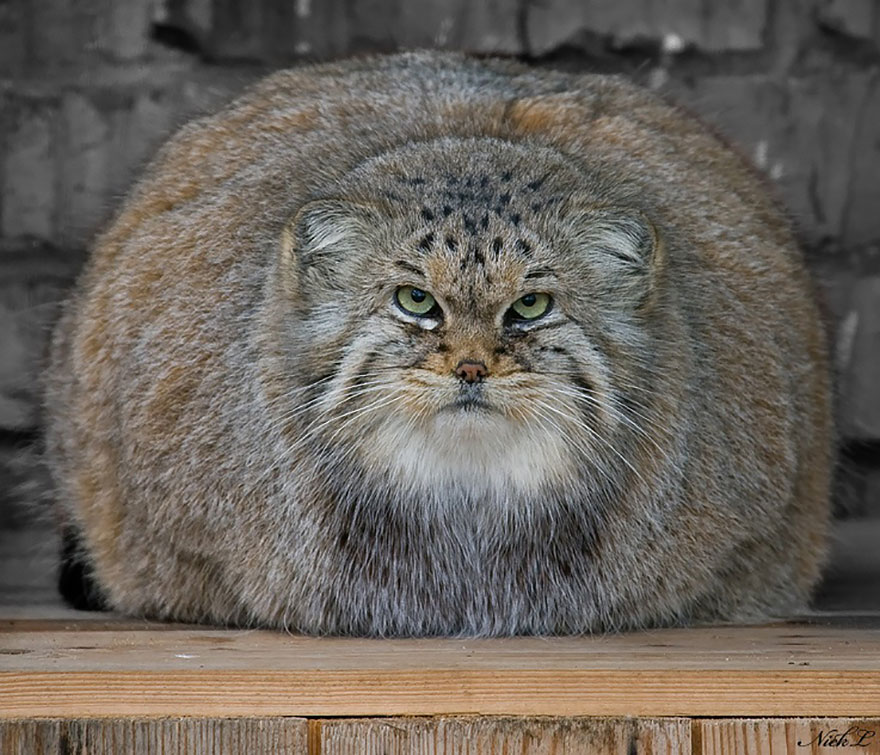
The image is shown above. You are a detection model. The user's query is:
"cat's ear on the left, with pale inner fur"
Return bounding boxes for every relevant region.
[281,199,380,288]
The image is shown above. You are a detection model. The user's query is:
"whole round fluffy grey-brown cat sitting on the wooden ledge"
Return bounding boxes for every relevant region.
[47,54,831,635]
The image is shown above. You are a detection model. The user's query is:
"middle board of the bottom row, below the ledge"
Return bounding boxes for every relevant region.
[315,717,691,755]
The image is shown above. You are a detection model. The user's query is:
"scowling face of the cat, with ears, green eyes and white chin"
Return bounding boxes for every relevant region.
[287,143,656,499]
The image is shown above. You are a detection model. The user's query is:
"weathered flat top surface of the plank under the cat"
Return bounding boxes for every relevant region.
[6,612,880,673]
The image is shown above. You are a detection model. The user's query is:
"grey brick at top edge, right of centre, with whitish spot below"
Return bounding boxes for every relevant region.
[526,0,768,55]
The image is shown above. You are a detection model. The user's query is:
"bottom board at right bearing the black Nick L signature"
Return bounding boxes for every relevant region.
[694,718,880,755]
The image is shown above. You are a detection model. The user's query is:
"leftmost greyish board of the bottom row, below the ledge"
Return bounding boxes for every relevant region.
[0,718,308,755]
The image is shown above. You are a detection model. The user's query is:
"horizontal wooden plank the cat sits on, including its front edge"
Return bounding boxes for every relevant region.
[0,615,880,718]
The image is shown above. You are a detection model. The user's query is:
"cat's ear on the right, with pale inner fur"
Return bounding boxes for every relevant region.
[563,203,664,307]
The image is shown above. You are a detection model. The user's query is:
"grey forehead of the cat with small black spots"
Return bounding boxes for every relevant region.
[340,139,583,288]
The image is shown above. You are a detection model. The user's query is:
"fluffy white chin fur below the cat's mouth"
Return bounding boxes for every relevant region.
[361,403,575,501]
